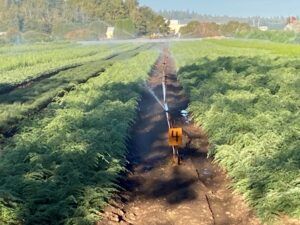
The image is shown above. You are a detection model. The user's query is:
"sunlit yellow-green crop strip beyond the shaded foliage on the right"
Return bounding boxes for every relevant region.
[172,39,300,67]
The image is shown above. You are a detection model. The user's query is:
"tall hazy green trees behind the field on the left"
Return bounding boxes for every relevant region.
[0,0,168,41]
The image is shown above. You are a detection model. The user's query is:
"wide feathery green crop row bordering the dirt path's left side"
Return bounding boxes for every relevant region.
[0,50,158,225]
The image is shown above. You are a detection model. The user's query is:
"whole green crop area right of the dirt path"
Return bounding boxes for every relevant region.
[171,40,300,223]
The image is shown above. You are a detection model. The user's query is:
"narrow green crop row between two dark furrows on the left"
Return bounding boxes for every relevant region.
[0,42,144,136]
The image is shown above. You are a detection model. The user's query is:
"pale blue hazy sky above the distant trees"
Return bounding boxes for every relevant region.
[139,0,300,16]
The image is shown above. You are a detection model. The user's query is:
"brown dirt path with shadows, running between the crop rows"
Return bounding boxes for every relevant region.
[98,45,259,225]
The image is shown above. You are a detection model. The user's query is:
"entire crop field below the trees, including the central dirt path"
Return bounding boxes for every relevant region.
[0,39,300,225]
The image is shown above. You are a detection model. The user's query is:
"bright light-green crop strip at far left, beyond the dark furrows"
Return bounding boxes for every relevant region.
[0,44,132,90]
